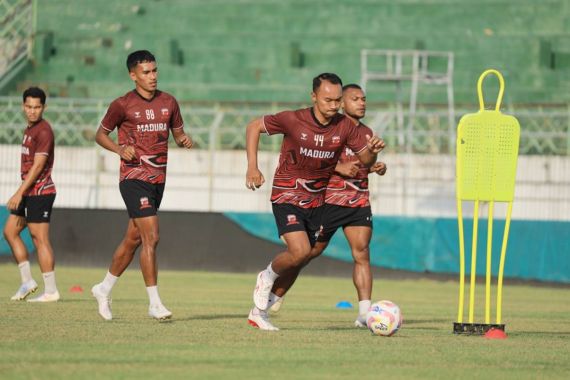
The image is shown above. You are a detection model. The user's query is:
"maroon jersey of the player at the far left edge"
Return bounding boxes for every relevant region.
[20,119,55,196]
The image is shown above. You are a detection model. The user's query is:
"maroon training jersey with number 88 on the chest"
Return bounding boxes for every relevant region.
[101,90,184,184]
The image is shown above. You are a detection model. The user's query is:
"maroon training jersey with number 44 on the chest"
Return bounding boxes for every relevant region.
[263,108,367,208]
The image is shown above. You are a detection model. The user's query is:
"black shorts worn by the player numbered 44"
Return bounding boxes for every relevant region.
[273,203,324,247]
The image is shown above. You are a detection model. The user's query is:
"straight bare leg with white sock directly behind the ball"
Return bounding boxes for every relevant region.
[344,226,373,327]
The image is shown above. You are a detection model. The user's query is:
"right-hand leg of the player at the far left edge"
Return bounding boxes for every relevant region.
[28,223,59,302]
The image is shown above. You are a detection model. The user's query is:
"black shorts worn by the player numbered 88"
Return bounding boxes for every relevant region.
[119,179,164,219]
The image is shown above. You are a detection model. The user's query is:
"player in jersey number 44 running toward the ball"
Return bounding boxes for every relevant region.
[242,73,384,331]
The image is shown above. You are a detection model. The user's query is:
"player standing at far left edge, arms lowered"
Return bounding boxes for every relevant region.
[4,87,59,302]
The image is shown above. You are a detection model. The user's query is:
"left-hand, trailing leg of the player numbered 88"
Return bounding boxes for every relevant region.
[91,219,141,320]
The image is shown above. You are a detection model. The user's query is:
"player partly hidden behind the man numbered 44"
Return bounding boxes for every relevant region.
[271,84,386,327]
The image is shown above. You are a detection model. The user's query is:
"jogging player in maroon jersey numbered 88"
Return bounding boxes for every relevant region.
[91,50,192,320]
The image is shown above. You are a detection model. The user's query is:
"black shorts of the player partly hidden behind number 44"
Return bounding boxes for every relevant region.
[318,204,372,242]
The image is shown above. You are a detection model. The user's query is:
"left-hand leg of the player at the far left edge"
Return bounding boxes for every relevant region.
[4,214,38,301]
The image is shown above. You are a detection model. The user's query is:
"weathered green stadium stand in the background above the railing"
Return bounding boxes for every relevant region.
[4,0,570,104]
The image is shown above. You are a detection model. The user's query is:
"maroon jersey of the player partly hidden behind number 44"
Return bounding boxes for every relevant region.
[325,124,374,207]
